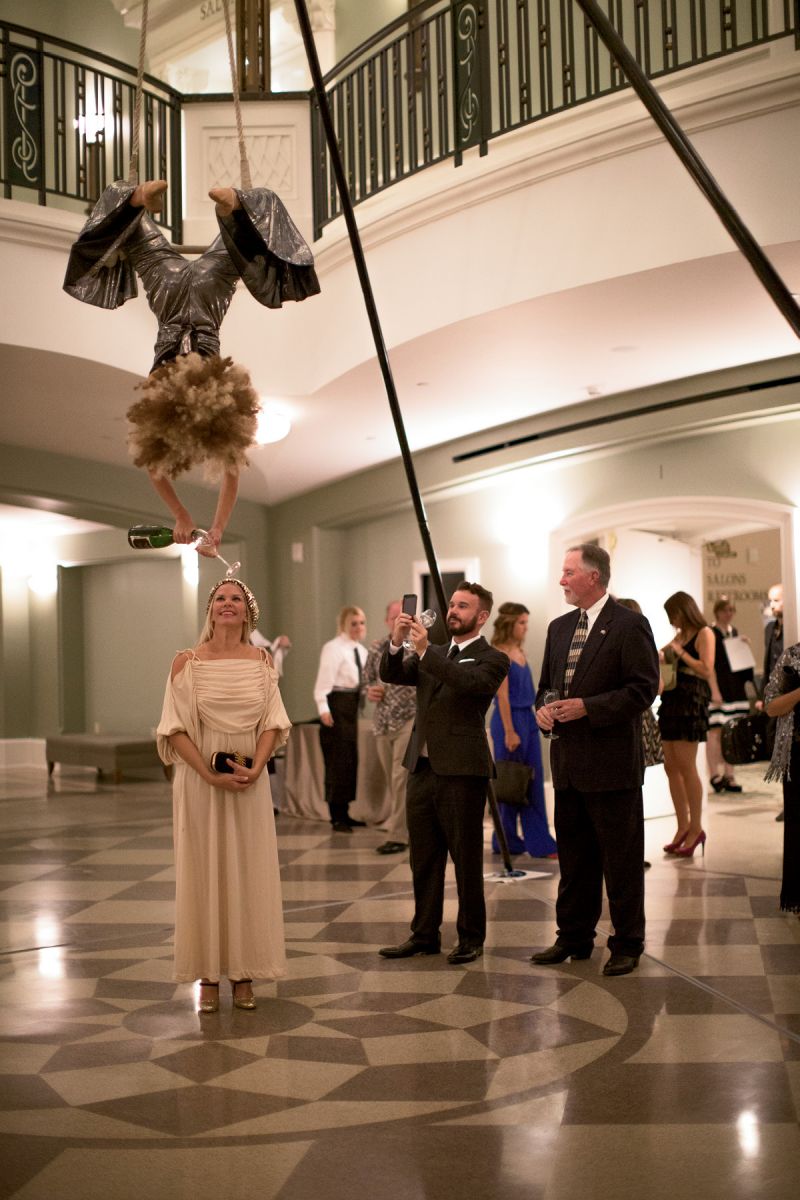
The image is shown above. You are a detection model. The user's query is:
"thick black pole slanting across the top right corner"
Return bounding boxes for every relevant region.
[577,0,800,337]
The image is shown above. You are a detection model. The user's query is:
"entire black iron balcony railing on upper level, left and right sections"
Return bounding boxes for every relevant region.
[0,0,800,242]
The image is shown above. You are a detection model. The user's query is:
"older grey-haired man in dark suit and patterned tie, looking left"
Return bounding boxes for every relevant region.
[531,544,658,976]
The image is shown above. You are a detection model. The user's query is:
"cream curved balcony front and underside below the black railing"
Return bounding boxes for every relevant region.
[0,0,800,503]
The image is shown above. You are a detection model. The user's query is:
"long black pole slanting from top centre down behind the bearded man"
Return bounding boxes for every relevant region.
[295,0,525,876]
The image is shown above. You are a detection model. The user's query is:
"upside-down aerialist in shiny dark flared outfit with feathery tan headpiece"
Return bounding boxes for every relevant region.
[64,180,319,556]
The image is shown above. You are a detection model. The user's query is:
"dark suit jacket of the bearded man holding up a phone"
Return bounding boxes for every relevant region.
[380,637,510,779]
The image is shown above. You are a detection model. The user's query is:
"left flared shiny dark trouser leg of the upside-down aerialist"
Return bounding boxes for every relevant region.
[64,182,145,308]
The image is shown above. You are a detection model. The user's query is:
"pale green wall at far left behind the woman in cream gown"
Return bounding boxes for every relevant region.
[0,445,269,737]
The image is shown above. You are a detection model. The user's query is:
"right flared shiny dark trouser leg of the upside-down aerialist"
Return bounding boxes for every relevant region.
[217,187,319,308]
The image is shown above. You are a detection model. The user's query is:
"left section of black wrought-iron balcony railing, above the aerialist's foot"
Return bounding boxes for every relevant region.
[0,22,181,241]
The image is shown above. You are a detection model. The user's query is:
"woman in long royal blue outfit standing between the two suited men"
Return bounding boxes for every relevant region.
[489,601,558,858]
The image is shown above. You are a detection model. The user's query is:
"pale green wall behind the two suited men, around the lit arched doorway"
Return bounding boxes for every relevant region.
[269,360,800,718]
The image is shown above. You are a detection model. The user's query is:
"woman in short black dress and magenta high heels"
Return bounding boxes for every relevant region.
[658,592,715,858]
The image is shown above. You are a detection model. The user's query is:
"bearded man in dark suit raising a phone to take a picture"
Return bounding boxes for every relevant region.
[379,581,510,964]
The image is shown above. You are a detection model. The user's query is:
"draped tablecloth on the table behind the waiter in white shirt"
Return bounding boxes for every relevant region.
[281,720,389,826]
